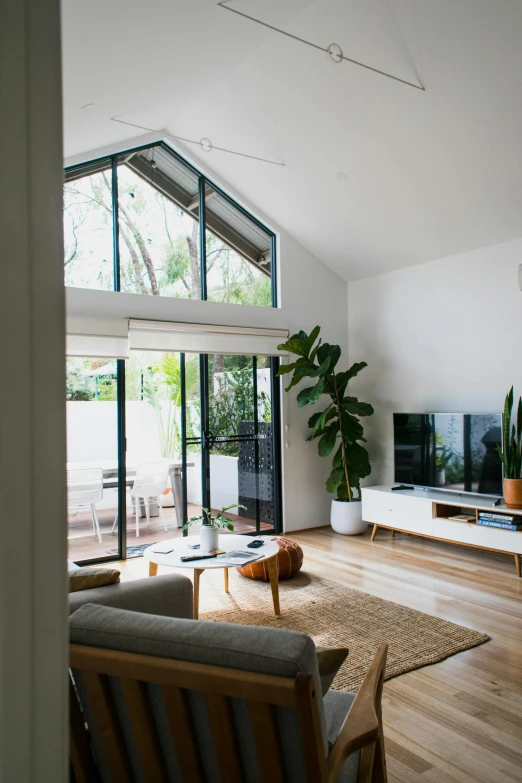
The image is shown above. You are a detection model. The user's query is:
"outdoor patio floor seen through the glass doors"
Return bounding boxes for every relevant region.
[68,504,272,562]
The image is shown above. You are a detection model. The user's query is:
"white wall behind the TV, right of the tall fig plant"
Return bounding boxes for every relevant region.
[348,239,522,485]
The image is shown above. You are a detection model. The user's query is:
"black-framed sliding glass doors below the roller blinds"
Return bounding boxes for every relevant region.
[67,351,281,562]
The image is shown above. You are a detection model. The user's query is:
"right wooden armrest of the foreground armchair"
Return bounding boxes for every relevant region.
[327,644,388,783]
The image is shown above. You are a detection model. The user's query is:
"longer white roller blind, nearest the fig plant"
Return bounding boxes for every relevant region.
[129,319,288,356]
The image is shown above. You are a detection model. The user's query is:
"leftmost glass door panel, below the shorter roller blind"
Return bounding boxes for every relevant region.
[66,358,119,562]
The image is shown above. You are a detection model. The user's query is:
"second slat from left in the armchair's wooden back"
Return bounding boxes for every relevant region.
[120,679,167,783]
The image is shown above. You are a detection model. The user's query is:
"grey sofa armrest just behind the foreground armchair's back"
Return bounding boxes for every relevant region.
[69,574,193,620]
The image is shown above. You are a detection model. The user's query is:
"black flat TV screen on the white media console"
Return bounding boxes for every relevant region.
[393,413,502,496]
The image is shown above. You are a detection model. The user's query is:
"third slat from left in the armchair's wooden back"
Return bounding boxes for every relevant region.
[161,685,202,783]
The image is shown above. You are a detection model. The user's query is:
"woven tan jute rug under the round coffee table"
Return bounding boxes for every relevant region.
[199,568,489,691]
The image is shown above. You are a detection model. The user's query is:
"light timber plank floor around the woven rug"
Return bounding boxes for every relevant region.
[116,527,522,783]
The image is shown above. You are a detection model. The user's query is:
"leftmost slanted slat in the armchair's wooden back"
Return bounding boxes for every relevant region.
[82,671,132,783]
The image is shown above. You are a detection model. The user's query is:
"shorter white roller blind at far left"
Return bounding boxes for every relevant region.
[66,317,129,359]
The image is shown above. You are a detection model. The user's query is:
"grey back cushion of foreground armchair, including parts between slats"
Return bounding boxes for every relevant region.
[69,604,328,783]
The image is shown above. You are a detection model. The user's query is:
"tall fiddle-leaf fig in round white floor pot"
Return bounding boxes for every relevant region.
[278,326,373,535]
